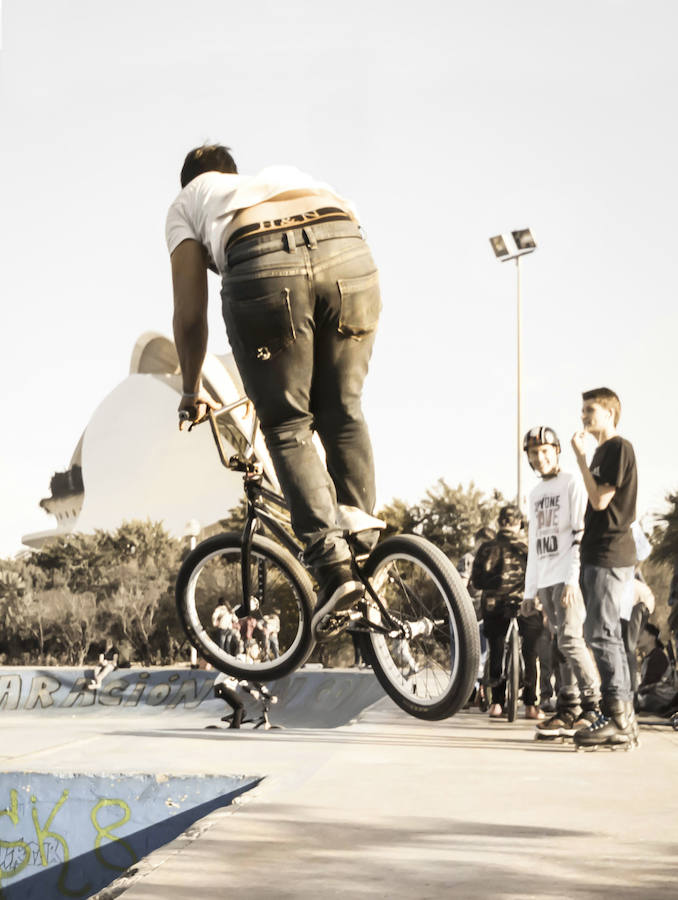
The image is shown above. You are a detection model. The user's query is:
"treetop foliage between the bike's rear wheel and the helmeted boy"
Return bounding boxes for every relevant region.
[379,478,506,562]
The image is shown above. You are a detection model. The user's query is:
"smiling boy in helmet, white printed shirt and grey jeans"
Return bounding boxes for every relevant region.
[523,425,600,738]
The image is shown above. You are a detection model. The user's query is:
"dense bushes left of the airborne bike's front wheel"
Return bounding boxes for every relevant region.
[0,522,183,665]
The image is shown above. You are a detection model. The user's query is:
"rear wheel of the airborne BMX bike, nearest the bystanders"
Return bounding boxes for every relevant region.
[363,535,480,721]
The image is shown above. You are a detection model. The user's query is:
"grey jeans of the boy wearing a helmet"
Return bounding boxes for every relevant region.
[537,582,600,709]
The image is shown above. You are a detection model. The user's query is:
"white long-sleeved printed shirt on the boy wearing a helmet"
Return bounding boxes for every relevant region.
[525,472,588,597]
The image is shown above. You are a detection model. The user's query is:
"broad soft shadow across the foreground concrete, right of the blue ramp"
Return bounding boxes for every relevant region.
[126,800,678,900]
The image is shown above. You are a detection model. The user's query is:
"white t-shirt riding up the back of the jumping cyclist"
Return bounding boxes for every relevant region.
[165,166,357,273]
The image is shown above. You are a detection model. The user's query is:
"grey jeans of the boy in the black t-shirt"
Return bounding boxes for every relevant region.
[579,563,633,711]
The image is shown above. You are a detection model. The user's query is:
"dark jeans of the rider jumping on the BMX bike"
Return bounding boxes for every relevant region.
[221,221,381,568]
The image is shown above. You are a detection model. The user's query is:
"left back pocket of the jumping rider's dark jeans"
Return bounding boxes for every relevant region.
[229,288,296,362]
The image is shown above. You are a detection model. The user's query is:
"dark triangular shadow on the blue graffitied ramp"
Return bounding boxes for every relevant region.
[0,778,262,900]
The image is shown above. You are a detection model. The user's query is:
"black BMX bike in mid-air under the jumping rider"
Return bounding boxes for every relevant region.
[176,397,480,720]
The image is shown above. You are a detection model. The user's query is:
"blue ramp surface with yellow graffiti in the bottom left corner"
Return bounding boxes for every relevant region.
[0,772,261,900]
